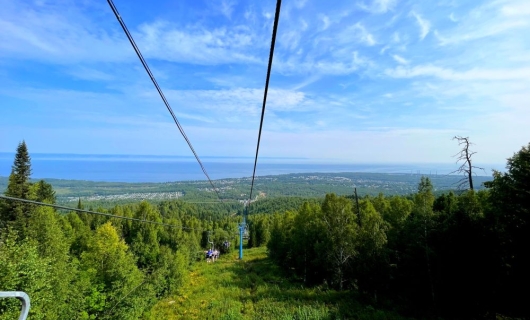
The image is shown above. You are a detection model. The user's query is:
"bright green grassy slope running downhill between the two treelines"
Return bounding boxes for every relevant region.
[151,248,401,319]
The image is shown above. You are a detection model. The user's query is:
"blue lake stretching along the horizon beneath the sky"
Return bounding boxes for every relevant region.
[0,153,491,182]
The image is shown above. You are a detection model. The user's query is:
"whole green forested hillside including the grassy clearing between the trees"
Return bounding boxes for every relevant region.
[0,142,530,319]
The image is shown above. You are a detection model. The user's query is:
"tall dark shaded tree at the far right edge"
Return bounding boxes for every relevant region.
[486,143,530,315]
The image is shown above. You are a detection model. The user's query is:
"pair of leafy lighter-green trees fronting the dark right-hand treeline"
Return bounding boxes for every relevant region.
[267,194,390,291]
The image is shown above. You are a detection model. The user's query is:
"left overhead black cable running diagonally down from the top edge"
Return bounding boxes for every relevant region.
[107,0,221,198]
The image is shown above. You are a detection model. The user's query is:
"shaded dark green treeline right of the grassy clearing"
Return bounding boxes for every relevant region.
[249,144,530,319]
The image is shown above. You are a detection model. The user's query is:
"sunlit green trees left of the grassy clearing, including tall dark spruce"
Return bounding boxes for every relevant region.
[0,143,238,319]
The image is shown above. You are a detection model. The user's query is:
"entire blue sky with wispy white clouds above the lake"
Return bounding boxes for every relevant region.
[0,0,530,164]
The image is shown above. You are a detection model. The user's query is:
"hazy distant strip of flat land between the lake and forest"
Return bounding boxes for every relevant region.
[0,172,492,203]
